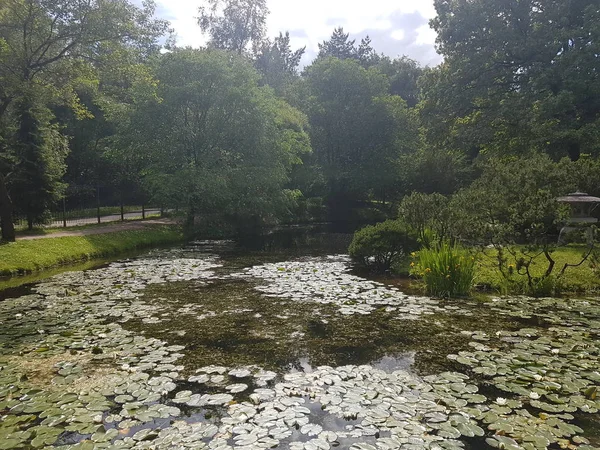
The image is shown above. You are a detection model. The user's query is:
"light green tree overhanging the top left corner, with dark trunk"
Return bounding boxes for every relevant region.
[0,0,167,240]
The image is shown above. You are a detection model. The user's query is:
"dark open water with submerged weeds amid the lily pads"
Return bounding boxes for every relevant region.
[124,278,506,374]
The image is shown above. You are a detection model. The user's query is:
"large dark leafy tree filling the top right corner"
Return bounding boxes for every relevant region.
[423,0,600,159]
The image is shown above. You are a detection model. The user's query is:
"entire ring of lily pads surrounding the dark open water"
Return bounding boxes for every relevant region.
[0,246,600,450]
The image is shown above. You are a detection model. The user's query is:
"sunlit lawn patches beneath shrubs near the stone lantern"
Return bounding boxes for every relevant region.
[475,245,600,293]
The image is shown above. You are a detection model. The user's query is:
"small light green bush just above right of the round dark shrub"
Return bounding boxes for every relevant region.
[398,192,450,246]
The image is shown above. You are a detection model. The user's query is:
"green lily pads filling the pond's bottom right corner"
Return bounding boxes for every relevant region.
[448,299,600,449]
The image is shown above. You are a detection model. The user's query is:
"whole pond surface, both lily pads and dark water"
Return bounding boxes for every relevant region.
[0,233,600,450]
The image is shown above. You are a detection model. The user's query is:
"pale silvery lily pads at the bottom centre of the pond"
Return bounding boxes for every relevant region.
[145,366,492,450]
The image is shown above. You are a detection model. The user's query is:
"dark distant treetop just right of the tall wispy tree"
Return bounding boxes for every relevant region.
[254,32,306,93]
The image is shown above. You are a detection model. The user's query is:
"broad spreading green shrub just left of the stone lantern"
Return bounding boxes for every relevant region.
[451,154,577,245]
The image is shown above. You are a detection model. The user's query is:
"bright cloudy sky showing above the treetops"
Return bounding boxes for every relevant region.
[151,0,442,66]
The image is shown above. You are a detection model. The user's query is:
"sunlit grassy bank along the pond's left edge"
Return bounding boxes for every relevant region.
[0,226,183,276]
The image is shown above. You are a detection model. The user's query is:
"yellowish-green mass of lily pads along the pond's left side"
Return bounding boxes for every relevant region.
[0,252,218,449]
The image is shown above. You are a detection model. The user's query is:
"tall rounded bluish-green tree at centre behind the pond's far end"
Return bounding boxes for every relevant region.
[301,58,418,220]
